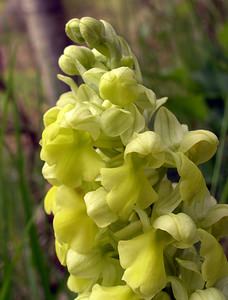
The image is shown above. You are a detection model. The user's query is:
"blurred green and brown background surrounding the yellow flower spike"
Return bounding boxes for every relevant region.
[0,0,228,300]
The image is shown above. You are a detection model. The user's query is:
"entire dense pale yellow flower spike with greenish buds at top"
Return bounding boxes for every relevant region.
[41,17,228,300]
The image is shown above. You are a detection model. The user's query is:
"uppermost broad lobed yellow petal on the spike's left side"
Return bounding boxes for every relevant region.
[41,124,104,187]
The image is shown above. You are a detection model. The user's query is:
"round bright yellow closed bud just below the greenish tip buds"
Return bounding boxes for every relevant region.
[99,67,139,107]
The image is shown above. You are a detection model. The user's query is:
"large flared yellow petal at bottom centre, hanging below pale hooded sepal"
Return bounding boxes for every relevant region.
[118,230,167,297]
